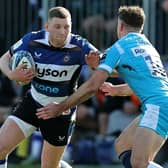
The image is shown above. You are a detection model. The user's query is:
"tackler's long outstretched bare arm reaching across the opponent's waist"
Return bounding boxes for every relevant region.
[36,70,108,119]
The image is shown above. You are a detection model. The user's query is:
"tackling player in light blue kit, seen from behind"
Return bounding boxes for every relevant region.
[37,6,168,168]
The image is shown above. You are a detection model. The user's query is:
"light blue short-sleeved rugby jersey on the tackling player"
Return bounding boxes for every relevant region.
[98,33,168,102]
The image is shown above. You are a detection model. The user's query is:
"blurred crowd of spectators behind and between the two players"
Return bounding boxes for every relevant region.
[0,0,168,167]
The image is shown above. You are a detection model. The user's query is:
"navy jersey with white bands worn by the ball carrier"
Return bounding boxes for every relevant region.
[10,30,97,105]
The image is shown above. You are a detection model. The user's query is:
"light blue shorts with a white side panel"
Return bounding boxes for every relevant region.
[139,99,168,139]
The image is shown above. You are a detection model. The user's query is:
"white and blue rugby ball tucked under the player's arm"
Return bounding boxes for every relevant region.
[10,50,35,85]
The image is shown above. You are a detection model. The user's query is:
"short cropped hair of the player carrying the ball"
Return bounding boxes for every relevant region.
[48,6,71,19]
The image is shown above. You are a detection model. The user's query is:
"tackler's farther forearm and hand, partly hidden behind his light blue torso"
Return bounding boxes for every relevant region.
[100,82,133,96]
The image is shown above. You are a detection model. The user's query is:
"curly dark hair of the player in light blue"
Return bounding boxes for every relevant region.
[118,6,145,28]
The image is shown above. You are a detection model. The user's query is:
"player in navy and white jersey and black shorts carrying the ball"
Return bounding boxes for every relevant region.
[0,7,99,168]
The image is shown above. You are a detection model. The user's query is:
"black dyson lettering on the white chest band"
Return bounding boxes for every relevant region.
[36,64,68,78]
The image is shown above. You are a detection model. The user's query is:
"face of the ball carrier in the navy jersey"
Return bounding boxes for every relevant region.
[46,17,71,47]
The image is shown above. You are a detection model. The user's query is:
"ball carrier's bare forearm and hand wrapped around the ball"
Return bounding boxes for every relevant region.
[0,51,33,82]
